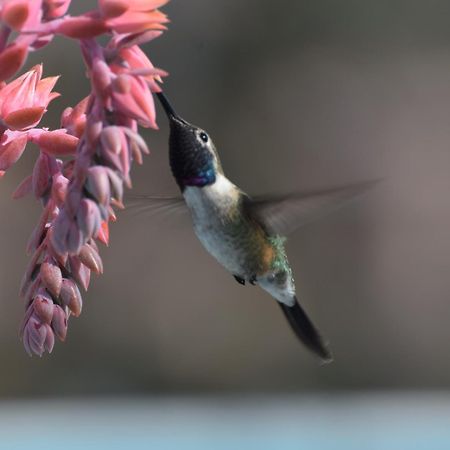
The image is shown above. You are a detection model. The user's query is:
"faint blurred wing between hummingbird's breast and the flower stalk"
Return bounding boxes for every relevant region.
[125,195,189,217]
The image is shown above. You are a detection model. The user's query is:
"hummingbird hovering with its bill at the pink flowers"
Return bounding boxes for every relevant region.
[135,93,373,362]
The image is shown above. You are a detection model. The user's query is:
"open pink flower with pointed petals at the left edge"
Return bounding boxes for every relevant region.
[0,65,59,130]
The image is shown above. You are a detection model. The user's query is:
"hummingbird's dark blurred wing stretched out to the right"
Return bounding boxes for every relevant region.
[246,180,379,236]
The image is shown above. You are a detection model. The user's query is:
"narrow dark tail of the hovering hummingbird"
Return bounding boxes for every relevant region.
[279,300,333,363]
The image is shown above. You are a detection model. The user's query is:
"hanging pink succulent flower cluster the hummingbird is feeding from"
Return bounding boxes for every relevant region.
[0,0,167,355]
